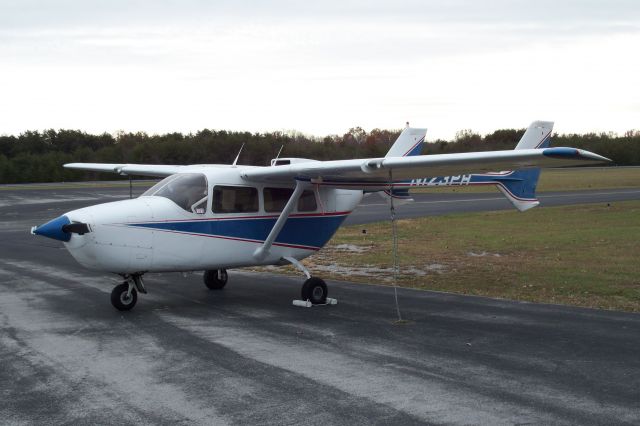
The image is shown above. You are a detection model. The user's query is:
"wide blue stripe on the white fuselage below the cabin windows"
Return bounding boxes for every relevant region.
[129,214,347,248]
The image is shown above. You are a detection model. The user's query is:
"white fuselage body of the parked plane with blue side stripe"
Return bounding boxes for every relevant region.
[57,168,363,274]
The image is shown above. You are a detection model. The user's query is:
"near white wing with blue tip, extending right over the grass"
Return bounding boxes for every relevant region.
[241,148,611,188]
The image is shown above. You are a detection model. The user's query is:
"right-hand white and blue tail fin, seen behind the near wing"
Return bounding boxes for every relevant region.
[487,121,553,212]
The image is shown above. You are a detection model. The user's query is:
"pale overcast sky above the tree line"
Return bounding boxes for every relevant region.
[0,0,640,140]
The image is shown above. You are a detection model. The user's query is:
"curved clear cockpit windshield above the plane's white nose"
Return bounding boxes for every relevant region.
[142,173,207,214]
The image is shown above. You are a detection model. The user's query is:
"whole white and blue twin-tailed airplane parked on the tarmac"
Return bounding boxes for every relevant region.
[31,121,610,310]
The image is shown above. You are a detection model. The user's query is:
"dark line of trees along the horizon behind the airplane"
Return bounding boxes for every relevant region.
[0,127,640,183]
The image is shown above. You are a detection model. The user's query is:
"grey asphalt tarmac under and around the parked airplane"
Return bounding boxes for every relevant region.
[0,184,640,425]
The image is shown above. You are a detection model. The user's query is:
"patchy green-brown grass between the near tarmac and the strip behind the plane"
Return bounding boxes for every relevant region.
[288,201,640,311]
